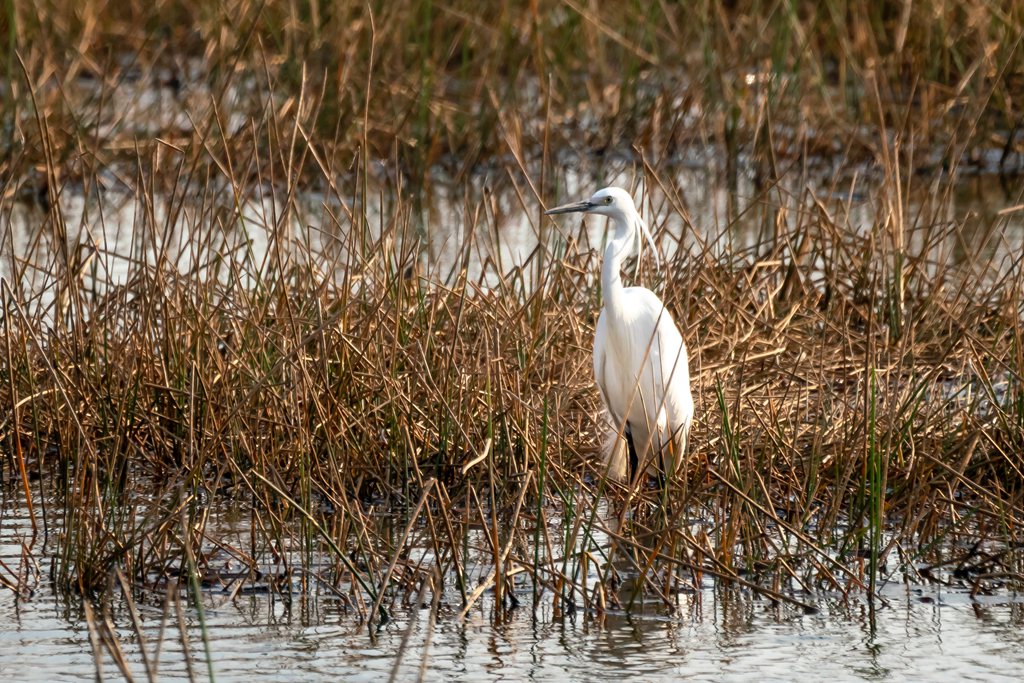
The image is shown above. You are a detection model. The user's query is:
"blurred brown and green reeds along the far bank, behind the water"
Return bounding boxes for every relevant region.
[0,0,1024,182]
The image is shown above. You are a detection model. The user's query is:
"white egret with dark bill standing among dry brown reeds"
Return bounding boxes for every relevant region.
[545,187,693,481]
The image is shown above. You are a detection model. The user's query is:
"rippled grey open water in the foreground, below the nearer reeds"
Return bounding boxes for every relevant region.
[0,498,1024,682]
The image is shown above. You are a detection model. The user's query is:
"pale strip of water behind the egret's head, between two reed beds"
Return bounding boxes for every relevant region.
[0,148,1024,319]
